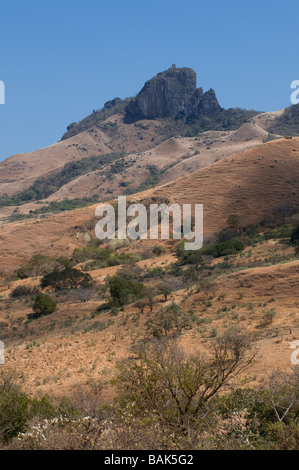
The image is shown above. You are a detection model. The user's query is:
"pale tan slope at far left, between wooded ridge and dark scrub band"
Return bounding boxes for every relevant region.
[0,115,165,195]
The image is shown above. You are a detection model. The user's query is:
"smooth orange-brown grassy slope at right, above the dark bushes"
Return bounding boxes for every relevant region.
[151,138,299,236]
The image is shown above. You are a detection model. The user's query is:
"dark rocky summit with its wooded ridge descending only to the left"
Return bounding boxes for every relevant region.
[62,65,223,140]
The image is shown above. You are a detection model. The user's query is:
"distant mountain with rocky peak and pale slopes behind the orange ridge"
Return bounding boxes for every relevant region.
[0,66,286,223]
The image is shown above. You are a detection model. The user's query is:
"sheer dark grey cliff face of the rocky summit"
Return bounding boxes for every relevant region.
[125,66,221,122]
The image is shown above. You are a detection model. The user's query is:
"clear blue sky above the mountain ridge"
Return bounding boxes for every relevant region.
[0,0,299,160]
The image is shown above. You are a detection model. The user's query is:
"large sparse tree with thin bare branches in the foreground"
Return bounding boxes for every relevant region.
[115,328,255,438]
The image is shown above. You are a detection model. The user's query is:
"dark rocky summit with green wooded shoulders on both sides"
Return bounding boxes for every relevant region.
[62,65,258,140]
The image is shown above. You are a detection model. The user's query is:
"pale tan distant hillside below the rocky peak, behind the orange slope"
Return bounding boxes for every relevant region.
[0,109,284,223]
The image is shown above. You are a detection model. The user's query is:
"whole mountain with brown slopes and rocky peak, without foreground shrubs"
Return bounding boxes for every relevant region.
[0,67,299,428]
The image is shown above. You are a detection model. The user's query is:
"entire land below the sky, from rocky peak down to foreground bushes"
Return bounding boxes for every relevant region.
[0,66,299,449]
